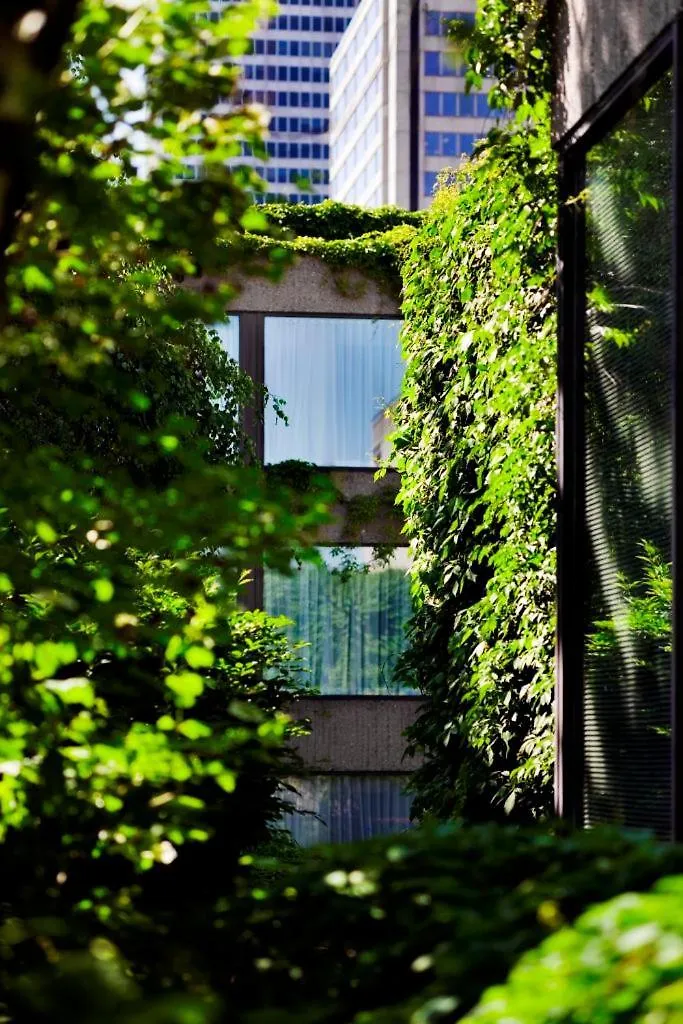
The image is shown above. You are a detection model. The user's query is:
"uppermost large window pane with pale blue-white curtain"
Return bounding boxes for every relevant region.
[265,316,403,467]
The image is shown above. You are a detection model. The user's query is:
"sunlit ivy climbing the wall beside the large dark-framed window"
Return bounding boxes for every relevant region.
[392,0,556,819]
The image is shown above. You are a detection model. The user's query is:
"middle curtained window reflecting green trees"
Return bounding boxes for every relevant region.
[263,547,412,696]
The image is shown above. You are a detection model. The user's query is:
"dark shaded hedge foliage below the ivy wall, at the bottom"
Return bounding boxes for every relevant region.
[223,823,683,1024]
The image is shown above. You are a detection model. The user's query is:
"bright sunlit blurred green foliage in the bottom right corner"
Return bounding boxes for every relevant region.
[467,876,683,1024]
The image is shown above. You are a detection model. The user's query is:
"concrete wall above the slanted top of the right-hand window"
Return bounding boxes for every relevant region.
[553,0,681,141]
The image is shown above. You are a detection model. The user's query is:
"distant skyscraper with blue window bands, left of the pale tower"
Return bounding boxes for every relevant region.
[206,0,356,203]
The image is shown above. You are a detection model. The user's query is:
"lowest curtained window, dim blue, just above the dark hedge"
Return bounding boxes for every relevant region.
[283,775,411,846]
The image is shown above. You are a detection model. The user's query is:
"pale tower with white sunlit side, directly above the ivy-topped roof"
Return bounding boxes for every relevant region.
[330,0,497,209]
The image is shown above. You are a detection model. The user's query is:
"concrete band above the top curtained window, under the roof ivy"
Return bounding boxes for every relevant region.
[229,256,400,316]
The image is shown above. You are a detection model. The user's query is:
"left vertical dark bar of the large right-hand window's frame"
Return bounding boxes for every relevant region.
[555,151,586,825]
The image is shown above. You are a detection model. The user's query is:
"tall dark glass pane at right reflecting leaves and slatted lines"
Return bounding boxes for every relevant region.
[584,76,673,835]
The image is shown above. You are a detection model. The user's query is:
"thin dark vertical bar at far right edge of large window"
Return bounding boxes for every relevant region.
[671,15,683,841]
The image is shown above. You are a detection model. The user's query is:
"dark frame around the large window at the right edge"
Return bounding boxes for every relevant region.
[555,15,683,841]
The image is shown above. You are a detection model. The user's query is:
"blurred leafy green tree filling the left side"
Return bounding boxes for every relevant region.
[0,0,325,1021]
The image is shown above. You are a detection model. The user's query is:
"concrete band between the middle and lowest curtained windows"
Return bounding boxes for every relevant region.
[291,697,422,772]
